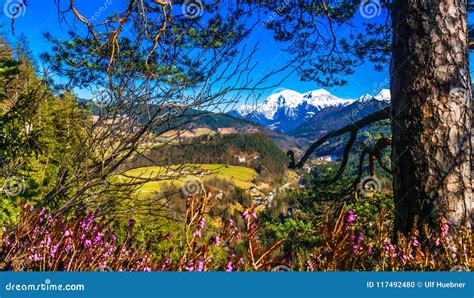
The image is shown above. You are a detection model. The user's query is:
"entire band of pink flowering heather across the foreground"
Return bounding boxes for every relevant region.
[0,205,474,272]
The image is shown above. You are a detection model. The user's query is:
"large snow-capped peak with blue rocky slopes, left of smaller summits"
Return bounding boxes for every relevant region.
[231,89,354,132]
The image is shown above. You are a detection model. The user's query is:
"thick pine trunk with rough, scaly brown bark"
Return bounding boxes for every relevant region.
[391,0,473,238]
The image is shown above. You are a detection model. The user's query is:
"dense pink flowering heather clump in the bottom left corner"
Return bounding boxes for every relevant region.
[0,207,153,271]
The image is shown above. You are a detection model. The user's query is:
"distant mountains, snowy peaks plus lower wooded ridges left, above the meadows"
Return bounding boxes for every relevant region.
[89,89,390,156]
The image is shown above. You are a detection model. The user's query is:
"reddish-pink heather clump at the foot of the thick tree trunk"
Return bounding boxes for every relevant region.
[305,211,474,271]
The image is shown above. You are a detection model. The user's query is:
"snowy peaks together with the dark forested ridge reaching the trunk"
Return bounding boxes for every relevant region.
[229,89,390,139]
